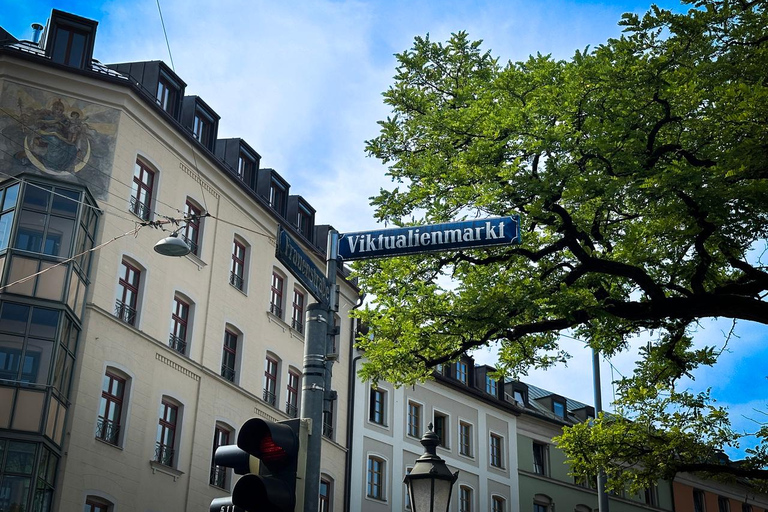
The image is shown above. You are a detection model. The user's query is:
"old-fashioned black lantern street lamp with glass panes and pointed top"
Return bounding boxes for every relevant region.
[403,423,459,512]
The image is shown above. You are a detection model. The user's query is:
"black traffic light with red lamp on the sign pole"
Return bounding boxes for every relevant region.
[210,418,308,512]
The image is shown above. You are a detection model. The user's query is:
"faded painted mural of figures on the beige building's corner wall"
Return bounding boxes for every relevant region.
[0,82,119,199]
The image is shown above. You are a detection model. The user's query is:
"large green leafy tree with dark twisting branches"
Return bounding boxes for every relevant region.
[356,0,768,486]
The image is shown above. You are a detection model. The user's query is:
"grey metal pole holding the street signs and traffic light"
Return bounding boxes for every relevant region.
[301,230,339,512]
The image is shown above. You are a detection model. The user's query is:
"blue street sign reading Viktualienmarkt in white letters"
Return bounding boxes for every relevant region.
[339,215,520,261]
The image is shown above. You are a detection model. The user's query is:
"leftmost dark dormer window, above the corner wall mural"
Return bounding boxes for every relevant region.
[45,9,97,69]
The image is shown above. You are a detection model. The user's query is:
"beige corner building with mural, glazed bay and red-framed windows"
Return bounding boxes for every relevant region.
[0,11,359,512]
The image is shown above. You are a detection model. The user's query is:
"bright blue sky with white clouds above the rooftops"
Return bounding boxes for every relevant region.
[0,0,768,457]
